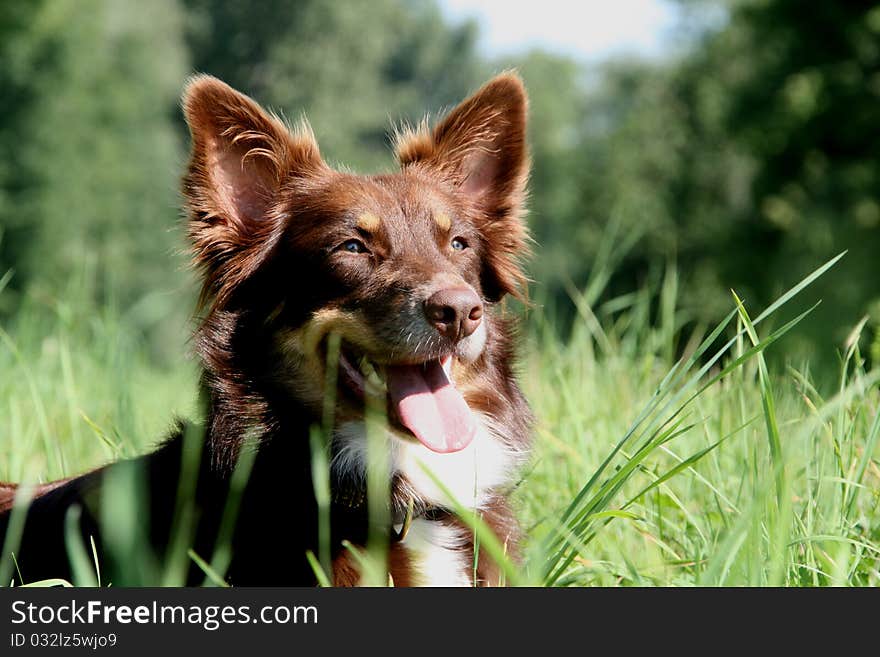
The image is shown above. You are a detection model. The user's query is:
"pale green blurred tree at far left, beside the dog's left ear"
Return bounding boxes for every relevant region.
[0,0,192,344]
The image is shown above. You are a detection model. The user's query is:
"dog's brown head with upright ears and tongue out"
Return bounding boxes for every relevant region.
[184,74,528,453]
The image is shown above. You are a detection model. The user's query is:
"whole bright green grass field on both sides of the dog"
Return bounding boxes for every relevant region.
[0,255,880,586]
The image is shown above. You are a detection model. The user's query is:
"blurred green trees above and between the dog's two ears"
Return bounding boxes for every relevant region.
[186,0,482,170]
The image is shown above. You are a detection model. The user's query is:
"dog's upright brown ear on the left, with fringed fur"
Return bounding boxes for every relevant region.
[183,75,325,304]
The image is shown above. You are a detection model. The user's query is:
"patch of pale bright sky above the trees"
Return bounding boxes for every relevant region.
[440,0,679,60]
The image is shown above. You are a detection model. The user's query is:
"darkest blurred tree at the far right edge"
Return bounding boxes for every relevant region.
[707,0,880,364]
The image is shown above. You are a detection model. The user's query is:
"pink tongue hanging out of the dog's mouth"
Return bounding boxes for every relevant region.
[387,360,477,454]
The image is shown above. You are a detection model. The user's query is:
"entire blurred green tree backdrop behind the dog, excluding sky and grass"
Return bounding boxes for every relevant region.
[0,0,880,379]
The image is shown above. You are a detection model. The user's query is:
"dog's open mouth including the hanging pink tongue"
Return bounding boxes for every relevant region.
[326,342,477,454]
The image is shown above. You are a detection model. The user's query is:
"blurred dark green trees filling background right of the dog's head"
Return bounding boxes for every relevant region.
[508,0,880,372]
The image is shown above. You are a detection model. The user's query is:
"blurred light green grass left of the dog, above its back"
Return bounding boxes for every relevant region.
[0,264,197,481]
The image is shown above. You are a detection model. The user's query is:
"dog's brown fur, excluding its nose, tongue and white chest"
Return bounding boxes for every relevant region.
[0,73,531,586]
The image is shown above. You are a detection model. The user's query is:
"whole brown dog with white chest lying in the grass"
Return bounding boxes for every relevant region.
[0,72,532,586]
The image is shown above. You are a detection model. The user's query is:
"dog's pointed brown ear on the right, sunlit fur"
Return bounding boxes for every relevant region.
[395,72,529,299]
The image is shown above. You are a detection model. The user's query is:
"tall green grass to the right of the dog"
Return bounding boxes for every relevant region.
[517,255,880,586]
